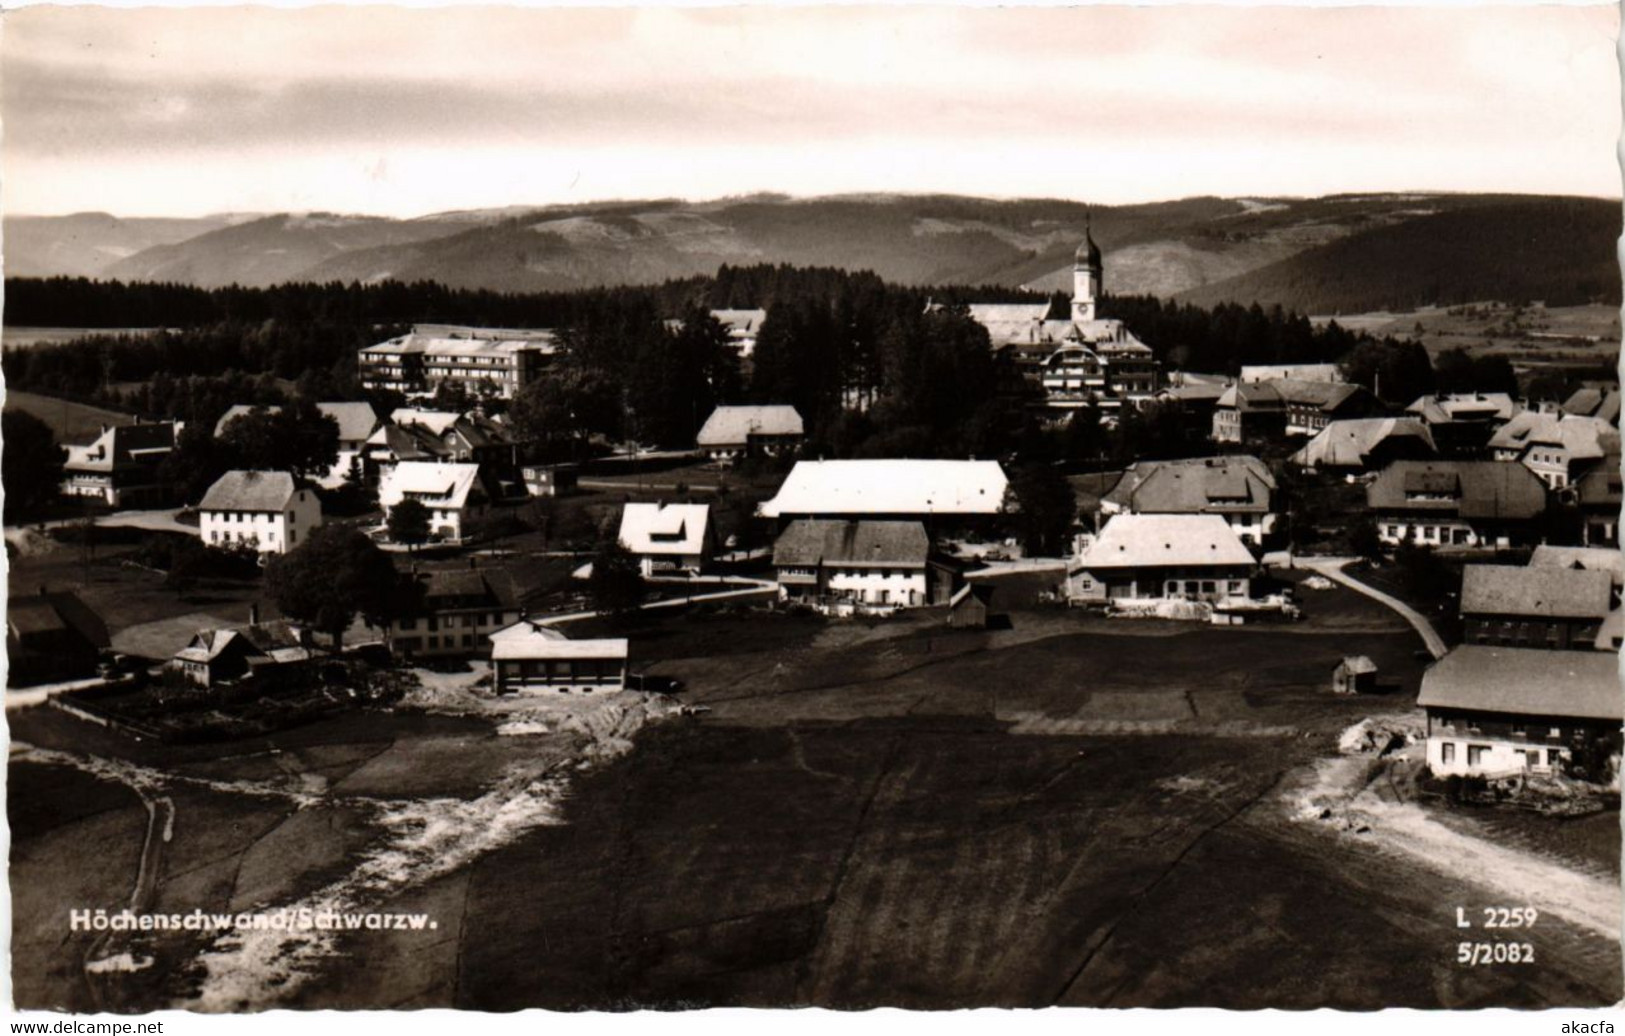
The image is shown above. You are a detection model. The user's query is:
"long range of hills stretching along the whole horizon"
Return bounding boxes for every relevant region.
[5,193,1620,313]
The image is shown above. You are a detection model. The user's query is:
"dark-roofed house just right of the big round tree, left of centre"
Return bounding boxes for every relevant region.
[388,568,520,658]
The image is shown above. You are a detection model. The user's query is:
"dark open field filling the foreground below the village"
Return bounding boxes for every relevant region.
[11,588,1620,1010]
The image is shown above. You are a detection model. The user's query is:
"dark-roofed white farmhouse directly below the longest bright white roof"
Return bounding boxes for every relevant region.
[774,518,957,612]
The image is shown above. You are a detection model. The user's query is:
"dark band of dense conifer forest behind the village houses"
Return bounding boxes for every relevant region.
[3,265,1560,467]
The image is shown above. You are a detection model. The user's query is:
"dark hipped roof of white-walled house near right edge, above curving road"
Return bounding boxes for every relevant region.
[1365,461,1545,520]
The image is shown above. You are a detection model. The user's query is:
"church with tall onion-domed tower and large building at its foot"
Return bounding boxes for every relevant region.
[967,227,1159,417]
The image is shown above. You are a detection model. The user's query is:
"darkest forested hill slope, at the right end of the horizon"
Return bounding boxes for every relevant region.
[1178,198,1620,313]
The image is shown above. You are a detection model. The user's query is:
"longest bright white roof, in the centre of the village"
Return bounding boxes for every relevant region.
[757,460,1009,531]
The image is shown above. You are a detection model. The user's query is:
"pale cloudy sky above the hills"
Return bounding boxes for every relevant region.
[0,5,1620,216]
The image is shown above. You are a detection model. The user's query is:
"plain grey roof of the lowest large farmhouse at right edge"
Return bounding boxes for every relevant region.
[1417,645,1622,723]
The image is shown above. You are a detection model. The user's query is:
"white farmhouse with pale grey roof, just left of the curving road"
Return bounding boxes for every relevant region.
[1066,515,1258,602]
